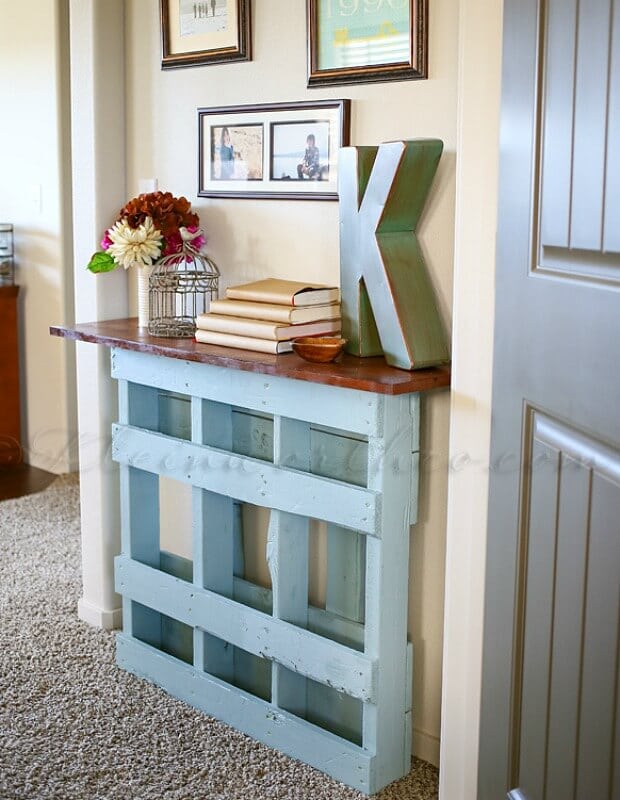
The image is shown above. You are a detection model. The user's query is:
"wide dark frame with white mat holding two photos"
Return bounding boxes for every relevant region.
[198,100,350,200]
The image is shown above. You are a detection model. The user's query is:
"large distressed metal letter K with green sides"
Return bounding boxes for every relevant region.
[338,139,450,369]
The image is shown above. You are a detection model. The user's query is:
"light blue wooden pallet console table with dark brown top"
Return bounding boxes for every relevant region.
[52,320,450,793]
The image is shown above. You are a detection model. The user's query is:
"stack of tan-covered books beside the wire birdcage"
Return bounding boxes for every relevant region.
[196,278,340,353]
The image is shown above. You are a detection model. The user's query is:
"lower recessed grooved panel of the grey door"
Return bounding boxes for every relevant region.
[509,404,620,800]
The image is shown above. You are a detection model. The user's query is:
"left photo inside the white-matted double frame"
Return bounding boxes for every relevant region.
[210,124,263,181]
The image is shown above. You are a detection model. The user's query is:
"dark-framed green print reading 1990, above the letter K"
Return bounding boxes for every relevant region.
[306,0,428,87]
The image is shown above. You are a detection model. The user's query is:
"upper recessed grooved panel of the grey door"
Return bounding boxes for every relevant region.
[531,0,620,285]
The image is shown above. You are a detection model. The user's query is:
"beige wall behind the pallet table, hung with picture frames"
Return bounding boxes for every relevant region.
[126,0,458,762]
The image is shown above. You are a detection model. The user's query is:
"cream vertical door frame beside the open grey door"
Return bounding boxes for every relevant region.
[439,0,503,800]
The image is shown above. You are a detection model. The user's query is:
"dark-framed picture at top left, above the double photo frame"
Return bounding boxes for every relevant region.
[159,0,251,69]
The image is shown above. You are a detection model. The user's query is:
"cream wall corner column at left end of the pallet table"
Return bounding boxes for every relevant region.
[68,0,128,629]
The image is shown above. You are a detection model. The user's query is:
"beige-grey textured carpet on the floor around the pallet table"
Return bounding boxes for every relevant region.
[0,477,437,800]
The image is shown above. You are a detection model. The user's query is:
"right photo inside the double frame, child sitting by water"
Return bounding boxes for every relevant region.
[271,121,330,181]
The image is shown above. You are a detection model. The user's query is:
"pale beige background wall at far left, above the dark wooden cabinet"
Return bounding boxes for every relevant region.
[0,0,76,473]
